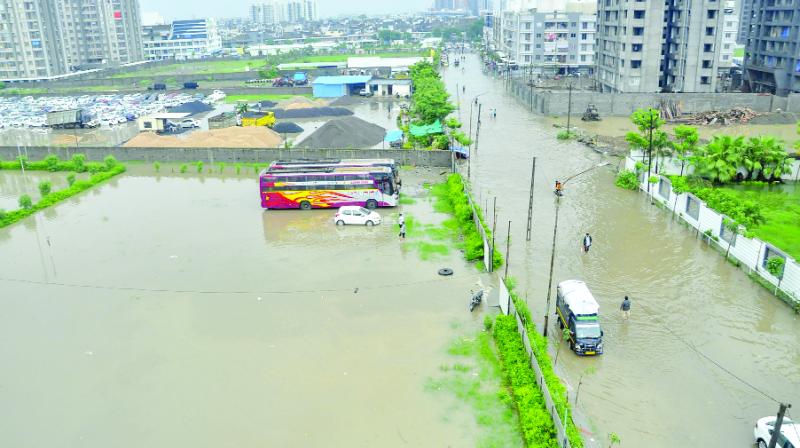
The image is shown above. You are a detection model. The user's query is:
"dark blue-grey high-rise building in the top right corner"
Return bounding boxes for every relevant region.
[744,0,800,96]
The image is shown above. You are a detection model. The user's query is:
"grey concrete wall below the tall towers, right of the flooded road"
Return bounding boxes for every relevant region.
[511,80,800,118]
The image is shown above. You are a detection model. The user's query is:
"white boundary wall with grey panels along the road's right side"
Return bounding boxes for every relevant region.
[625,157,800,304]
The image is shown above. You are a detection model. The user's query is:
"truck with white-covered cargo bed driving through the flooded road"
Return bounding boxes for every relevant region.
[556,280,603,356]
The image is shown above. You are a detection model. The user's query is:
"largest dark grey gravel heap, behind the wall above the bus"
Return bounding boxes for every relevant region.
[297,117,386,148]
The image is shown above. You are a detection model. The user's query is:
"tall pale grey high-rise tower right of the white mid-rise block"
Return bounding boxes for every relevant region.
[596,0,724,92]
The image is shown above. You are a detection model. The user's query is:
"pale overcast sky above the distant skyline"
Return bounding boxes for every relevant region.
[139,0,433,20]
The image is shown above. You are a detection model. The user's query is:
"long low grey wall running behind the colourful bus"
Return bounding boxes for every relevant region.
[0,146,451,167]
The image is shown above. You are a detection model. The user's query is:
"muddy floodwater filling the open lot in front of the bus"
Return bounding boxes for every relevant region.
[0,165,494,447]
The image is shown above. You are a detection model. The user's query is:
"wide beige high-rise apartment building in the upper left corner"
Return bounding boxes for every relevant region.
[0,0,143,79]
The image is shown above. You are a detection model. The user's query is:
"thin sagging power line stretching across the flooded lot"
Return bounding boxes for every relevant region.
[0,276,465,295]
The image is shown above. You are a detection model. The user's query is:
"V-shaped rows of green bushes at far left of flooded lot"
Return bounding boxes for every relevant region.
[0,154,125,228]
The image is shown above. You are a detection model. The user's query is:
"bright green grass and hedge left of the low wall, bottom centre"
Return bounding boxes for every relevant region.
[425,331,524,447]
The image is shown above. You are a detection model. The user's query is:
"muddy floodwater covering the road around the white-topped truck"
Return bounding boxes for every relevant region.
[444,55,800,447]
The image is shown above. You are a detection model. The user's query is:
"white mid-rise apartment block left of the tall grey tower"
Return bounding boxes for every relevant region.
[495,9,596,74]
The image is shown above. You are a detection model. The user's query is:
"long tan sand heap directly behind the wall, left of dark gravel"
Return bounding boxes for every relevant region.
[123,126,283,148]
